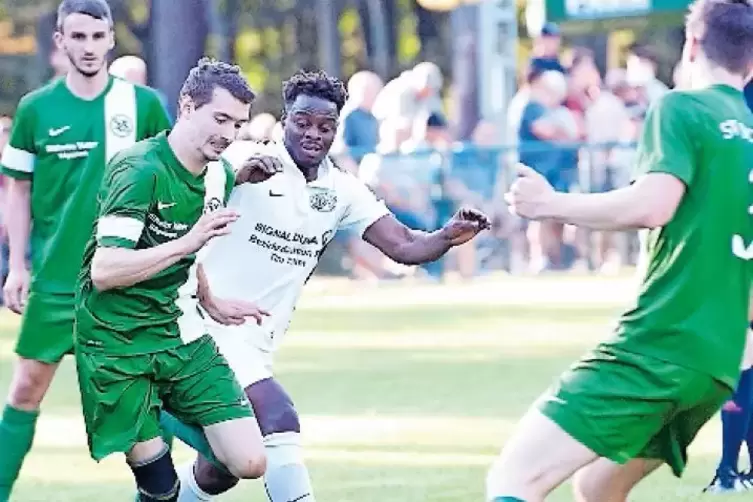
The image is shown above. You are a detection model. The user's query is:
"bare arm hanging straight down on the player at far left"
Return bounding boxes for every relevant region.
[3,177,31,314]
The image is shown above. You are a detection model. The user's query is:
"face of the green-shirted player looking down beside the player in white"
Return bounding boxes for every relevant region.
[180,87,251,162]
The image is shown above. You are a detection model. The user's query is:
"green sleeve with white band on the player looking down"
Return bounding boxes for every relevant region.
[97,158,155,249]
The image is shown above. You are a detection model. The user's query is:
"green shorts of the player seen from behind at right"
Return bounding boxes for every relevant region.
[539,346,732,477]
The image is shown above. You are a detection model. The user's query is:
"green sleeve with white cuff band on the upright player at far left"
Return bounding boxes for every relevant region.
[0,99,37,180]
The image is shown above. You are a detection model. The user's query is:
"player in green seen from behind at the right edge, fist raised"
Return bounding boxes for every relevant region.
[487,0,753,502]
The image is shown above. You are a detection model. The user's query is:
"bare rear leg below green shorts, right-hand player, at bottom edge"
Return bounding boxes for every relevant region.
[573,458,664,502]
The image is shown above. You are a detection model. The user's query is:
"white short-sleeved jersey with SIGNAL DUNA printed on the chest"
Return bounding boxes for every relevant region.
[189,141,389,350]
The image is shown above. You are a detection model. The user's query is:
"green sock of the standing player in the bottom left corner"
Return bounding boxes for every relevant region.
[0,404,39,502]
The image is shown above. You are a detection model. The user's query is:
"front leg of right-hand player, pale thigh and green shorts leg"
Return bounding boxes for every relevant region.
[488,347,680,502]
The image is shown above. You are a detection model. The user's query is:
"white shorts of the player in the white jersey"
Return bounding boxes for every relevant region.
[207,321,274,389]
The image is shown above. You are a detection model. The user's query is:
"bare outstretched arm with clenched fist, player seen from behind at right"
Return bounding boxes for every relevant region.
[505,164,685,230]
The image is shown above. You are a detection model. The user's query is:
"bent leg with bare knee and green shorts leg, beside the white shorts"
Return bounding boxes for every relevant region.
[161,336,266,479]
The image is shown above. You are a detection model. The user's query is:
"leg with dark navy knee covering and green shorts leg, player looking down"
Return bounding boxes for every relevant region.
[76,350,179,502]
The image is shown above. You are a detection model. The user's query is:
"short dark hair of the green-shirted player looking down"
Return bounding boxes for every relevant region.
[180,58,256,108]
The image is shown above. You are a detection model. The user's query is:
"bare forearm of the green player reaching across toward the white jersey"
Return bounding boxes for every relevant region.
[91,209,238,291]
